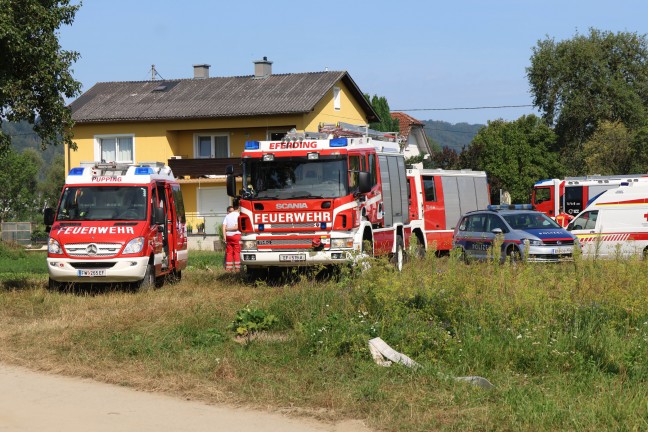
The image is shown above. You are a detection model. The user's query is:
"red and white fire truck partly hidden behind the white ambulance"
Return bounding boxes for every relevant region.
[531,174,648,218]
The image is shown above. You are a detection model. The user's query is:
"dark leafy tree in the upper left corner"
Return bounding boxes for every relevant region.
[0,0,81,154]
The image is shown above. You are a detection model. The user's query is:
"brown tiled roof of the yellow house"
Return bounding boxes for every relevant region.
[70,71,379,123]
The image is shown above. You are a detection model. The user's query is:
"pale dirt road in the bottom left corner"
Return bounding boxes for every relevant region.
[0,364,370,432]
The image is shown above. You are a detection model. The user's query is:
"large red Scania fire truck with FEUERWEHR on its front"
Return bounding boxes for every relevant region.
[227,123,409,275]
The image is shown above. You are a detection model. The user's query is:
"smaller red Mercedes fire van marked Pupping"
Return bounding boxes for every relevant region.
[45,162,188,289]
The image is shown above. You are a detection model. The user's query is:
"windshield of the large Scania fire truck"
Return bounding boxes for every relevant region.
[243,156,349,199]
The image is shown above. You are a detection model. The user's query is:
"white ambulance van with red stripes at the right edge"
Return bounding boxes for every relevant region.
[567,183,648,258]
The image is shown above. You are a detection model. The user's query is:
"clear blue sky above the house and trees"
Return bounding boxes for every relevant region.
[59,0,648,124]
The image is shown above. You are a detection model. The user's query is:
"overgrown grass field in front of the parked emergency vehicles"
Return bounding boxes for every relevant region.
[0,241,648,431]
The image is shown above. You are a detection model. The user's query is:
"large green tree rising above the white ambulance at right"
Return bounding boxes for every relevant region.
[526,29,648,174]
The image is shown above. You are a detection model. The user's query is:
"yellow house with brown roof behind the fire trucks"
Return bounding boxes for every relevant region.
[66,57,379,234]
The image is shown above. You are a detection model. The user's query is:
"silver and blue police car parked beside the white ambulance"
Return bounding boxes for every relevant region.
[452,204,579,262]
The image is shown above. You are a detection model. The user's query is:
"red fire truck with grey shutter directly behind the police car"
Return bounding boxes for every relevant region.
[407,168,490,255]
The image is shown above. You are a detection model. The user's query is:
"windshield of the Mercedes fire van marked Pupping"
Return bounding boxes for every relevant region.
[56,186,148,221]
